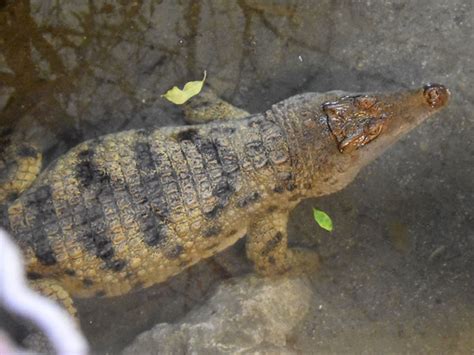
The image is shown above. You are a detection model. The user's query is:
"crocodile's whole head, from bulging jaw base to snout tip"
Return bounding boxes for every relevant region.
[290,84,450,196]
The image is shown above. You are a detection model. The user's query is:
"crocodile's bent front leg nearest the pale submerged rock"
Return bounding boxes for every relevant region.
[246,211,319,276]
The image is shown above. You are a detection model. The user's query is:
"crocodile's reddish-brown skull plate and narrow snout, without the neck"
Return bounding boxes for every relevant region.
[322,84,450,163]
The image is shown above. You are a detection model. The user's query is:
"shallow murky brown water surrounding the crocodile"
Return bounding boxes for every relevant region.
[0,0,474,353]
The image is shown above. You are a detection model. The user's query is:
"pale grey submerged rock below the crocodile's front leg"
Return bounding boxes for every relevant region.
[123,276,313,355]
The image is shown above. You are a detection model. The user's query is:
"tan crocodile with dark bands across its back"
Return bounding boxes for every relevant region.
[0,84,450,314]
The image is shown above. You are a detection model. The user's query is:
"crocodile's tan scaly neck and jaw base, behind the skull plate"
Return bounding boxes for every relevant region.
[266,93,362,201]
